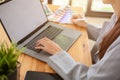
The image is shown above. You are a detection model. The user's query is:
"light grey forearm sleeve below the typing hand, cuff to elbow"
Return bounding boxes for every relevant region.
[47,51,88,80]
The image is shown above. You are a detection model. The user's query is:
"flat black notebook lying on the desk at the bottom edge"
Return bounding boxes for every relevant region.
[25,71,63,80]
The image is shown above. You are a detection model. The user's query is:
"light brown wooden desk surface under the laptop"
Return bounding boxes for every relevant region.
[0,5,92,80]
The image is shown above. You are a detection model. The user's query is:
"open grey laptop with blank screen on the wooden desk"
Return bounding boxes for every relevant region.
[0,0,81,62]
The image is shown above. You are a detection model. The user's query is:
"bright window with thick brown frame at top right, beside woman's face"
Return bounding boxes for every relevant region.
[86,0,113,17]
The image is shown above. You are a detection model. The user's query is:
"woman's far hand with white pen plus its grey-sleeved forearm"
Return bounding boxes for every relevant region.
[71,15,101,41]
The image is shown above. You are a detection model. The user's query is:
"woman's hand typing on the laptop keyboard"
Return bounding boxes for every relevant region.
[35,37,62,54]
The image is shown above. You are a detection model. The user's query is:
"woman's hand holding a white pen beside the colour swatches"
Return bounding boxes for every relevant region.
[71,14,87,27]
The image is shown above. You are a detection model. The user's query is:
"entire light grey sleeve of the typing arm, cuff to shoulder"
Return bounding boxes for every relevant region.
[47,43,120,80]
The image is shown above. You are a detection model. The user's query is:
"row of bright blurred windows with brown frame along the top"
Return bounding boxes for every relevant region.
[45,0,113,17]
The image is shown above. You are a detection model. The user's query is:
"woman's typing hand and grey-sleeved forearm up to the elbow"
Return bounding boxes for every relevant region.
[35,37,88,80]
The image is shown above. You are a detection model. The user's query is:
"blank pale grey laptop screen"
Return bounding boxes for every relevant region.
[0,0,47,42]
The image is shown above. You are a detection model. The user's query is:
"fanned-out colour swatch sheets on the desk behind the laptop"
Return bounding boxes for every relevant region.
[48,6,72,24]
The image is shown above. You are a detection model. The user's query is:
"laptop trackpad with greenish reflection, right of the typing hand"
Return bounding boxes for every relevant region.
[53,34,74,50]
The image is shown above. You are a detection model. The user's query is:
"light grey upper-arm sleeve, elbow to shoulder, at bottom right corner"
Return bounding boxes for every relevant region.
[87,44,120,80]
